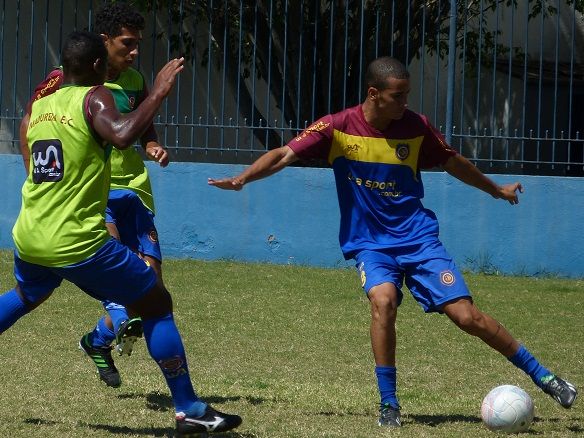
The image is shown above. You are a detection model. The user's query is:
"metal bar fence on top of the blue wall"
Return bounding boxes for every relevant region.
[0,0,584,176]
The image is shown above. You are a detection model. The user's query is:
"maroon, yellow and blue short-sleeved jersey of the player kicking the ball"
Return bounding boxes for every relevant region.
[288,105,456,259]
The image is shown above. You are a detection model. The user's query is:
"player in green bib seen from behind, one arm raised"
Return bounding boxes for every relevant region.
[0,32,241,434]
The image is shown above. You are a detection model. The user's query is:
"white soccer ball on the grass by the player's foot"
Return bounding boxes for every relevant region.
[481,385,533,433]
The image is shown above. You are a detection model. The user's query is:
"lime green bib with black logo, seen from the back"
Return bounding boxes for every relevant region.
[12,86,110,267]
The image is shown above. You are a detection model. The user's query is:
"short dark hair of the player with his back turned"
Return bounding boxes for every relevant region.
[61,31,107,77]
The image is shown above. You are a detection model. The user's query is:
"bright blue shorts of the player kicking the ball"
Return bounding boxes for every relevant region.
[354,239,472,312]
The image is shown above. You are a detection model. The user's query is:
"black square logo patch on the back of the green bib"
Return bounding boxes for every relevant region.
[31,138,64,184]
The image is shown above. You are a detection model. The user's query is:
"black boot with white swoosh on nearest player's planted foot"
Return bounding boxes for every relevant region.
[176,405,241,437]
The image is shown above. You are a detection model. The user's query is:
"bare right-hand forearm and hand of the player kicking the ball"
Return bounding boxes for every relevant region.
[442,154,523,205]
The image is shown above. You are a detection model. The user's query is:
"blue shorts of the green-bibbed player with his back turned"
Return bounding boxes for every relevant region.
[14,238,156,305]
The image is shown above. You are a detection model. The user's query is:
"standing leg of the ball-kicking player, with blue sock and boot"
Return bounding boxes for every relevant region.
[367,283,401,427]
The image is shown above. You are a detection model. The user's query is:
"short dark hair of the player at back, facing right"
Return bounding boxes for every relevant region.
[93,1,144,38]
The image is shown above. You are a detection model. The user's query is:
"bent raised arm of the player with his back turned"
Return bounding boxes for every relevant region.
[89,58,184,149]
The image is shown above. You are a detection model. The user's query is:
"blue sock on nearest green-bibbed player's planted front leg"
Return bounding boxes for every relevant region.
[142,313,207,417]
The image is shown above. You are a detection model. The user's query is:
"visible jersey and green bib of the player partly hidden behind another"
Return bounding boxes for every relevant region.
[27,67,154,212]
